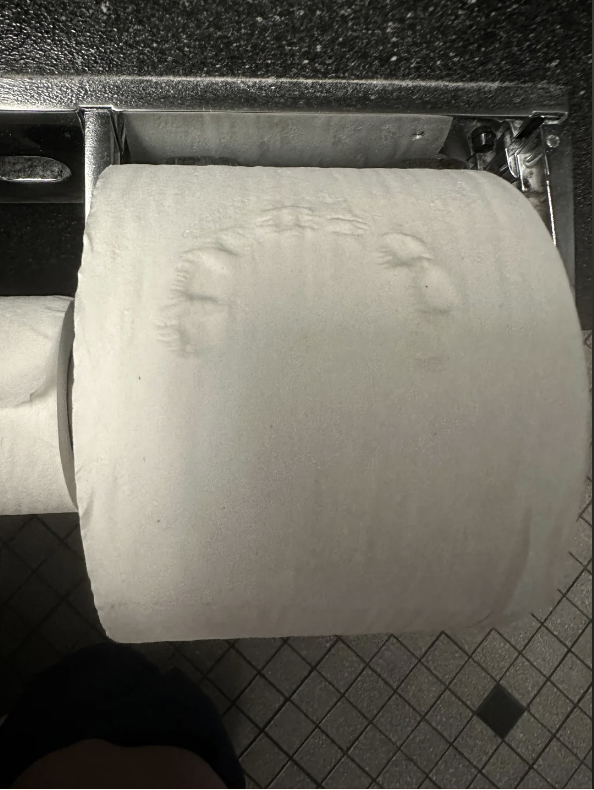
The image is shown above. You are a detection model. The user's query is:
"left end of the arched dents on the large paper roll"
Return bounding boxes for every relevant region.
[157,242,236,357]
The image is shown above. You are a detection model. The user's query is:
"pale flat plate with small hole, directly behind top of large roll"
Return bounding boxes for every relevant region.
[122,112,452,167]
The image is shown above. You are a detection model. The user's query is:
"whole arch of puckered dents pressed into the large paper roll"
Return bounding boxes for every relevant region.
[157,213,460,358]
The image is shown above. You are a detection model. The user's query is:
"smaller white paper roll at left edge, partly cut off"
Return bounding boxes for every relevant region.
[0,296,76,515]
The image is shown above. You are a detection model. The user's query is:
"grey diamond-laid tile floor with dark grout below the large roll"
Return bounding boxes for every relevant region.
[0,333,592,788]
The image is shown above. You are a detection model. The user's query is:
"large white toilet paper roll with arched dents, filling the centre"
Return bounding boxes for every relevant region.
[73,165,588,642]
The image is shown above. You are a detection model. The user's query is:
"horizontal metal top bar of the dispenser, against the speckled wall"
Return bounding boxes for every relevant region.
[0,75,568,119]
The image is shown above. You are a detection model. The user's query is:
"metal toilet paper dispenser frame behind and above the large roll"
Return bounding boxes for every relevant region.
[0,76,575,287]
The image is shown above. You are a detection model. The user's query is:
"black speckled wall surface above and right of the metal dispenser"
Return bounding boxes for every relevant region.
[0,0,592,327]
